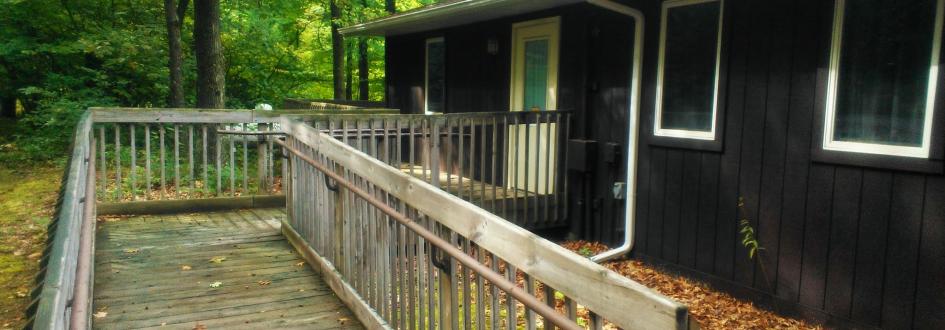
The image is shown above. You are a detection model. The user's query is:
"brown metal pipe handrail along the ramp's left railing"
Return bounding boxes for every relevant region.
[69,139,96,330]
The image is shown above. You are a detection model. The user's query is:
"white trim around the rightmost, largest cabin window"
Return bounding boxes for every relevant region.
[823,0,945,158]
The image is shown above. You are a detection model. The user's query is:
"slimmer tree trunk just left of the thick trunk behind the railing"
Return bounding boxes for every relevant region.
[164,0,188,108]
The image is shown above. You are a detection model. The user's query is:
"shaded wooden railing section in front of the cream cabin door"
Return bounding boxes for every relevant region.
[304,111,570,229]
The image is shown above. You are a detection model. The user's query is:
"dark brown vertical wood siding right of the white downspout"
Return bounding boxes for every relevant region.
[632,0,945,328]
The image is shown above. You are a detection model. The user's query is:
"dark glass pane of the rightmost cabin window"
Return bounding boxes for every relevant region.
[834,0,936,146]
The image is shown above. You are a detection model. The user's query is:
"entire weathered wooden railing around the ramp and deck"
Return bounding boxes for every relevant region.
[28,108,688,329]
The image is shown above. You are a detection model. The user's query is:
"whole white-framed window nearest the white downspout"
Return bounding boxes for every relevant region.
[653,0,722,140]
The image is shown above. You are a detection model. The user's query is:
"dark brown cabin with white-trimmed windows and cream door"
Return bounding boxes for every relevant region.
[342,0,945,329]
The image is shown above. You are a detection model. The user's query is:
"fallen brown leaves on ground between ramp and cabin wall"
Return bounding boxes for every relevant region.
[562,241,822,329]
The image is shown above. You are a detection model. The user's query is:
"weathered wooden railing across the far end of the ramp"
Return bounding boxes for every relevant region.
[92,108,396,202]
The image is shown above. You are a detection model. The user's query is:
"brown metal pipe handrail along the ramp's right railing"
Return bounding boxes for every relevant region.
[275,140,583,330]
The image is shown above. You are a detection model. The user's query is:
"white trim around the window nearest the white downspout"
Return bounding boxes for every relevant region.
[653,0,725,141]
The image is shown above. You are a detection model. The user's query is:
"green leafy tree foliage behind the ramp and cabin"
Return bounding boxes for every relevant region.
[0,0,435,163]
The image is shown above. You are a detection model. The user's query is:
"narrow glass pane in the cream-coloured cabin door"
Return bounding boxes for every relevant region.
[522,39,548,111]
